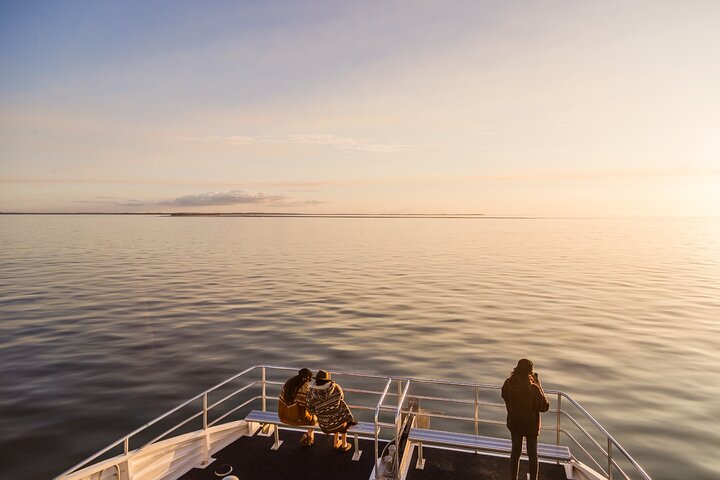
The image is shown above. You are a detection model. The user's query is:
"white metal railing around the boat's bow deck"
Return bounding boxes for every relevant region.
[55,365,652,480]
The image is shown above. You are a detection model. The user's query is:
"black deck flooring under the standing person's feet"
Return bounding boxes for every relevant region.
[407,446,567,480]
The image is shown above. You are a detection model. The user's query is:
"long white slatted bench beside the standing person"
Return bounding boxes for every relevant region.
[408,428,572,470]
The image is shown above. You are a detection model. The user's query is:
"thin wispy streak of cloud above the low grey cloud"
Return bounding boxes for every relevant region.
[183,133,418,153]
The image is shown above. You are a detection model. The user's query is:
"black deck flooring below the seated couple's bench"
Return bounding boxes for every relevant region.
[180,429,382,480]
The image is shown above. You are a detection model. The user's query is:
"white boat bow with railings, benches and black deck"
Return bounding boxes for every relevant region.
[55,365,651,480]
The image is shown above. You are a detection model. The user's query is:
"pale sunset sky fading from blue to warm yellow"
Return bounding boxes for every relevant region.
[0,0,720,216]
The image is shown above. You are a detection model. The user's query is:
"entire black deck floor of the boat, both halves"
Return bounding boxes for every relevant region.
[180,429,567,480]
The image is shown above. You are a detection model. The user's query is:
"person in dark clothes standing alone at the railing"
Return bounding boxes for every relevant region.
[502,358,550,480]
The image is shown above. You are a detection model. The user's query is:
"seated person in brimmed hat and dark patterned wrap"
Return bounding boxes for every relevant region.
[307,370,357,452]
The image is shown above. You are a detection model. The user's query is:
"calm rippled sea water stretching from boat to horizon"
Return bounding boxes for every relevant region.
[0,216,720,480]
